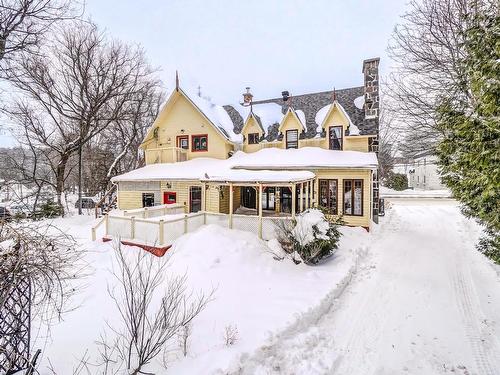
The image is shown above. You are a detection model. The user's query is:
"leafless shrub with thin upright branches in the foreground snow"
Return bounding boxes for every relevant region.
[102,247,214,375]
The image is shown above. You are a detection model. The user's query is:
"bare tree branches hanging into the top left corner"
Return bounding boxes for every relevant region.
[0,0,80,61]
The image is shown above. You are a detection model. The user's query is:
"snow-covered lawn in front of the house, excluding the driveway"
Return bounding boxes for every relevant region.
[34,213,370,374]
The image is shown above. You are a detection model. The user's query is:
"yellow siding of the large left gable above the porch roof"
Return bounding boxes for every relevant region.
[144,92,233,164]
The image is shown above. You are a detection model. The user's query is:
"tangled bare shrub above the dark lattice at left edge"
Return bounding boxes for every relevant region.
[0,221,81,319]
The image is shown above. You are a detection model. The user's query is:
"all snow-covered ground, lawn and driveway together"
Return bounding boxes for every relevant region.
[30,200,500,375]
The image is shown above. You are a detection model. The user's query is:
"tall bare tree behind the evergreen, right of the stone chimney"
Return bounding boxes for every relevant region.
[386,0,498,152]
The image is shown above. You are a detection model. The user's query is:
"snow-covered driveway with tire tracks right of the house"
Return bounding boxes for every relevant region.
[225,201,500,375]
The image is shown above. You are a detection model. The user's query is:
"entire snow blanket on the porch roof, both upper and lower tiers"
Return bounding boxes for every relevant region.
[111,147,378,182]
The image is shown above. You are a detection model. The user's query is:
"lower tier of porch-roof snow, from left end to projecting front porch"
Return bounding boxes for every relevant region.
[111,158,315,183]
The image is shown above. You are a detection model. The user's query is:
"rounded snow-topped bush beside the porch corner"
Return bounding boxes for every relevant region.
[278,209,341,265]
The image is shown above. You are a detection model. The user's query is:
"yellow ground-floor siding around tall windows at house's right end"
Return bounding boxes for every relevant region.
[313,169,372,227]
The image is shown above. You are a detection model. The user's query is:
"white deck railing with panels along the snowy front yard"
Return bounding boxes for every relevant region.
[92,210,291,247]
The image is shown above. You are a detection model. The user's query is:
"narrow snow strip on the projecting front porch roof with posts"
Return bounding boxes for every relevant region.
[201,169,316,184]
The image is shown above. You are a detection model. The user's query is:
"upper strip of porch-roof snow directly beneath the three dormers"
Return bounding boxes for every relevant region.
[232,147,378,170]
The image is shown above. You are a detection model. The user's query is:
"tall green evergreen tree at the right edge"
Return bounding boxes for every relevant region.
[437,8,500,263]
